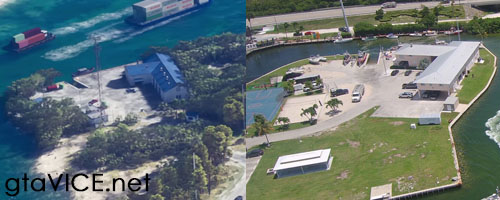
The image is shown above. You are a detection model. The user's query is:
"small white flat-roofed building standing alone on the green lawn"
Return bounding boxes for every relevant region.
[273,149,332,178]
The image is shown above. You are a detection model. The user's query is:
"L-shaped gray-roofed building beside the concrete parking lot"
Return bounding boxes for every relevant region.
[394,41,480,95]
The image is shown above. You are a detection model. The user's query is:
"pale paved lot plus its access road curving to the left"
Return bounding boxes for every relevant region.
[246,57,445,148]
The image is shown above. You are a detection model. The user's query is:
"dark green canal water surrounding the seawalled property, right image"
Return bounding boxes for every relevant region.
[247,35,500,200]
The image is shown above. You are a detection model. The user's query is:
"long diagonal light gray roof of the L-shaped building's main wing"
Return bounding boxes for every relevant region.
[414,41,480,84]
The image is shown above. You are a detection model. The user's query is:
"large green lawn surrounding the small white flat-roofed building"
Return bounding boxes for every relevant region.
[247,108,457,200]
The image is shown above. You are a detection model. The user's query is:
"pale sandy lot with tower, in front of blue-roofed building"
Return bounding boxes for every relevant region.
[35,66,160,123]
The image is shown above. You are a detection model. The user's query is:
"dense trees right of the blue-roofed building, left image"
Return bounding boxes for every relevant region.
[143,33,246,132]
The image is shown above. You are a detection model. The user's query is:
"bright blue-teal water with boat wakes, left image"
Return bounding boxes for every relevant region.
[0,0,245,200]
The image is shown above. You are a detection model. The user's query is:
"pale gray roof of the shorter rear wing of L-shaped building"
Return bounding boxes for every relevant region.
[394,44,456,56]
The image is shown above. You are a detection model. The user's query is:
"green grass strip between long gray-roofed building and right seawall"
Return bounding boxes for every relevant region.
[457,49,495,104]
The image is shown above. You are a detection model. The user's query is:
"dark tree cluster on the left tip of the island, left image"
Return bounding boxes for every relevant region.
[5,68,89,150]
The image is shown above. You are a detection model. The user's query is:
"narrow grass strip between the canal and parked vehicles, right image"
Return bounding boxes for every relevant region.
[247,55,344,91]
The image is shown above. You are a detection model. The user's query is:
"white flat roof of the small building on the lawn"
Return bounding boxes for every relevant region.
[273,149,331,171]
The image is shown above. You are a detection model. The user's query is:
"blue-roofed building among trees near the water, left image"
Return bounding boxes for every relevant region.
[125,53,188,102]
